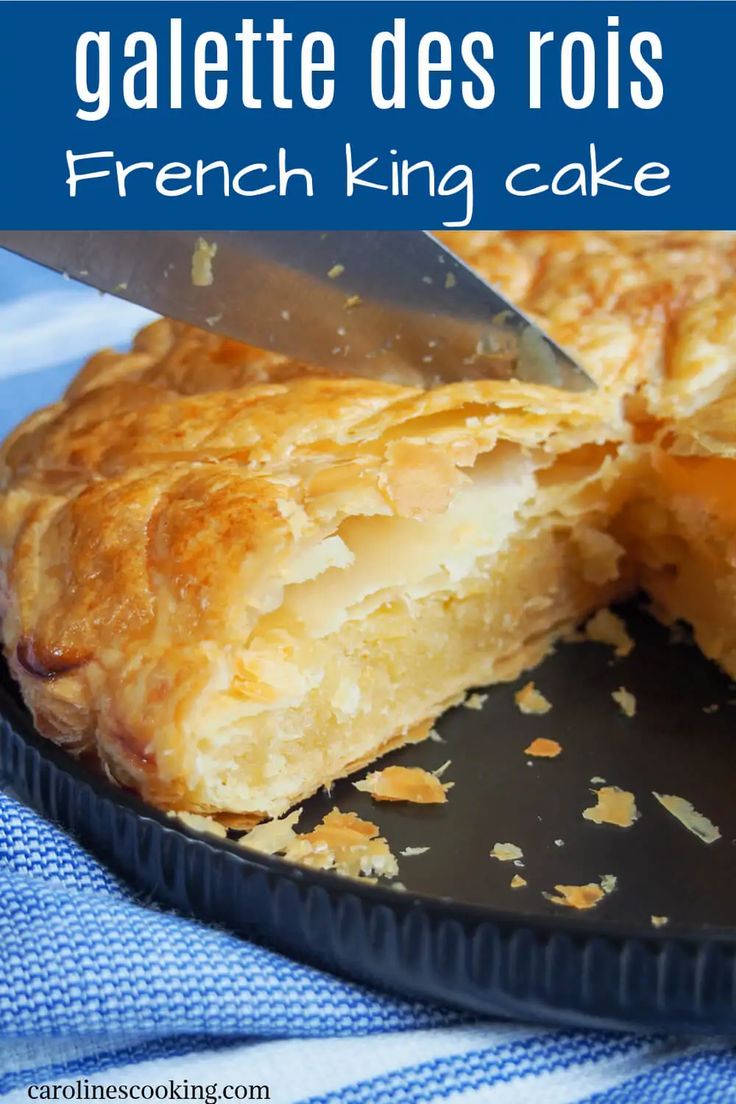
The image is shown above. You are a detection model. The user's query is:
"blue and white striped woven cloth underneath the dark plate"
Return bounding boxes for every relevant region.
[0,255,736,1104]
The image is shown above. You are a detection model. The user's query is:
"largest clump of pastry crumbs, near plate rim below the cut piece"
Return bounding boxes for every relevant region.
[284,808,398,878]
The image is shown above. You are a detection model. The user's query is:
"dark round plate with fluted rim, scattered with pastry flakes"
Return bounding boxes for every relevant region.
[0,604,736,1031]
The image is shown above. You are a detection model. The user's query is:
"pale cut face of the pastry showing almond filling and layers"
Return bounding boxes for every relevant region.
[108,434,628,817]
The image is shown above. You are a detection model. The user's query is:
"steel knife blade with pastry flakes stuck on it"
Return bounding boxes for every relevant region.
[0,231,594,391]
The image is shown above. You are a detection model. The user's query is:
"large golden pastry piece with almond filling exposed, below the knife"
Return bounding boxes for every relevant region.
[0,322,633,818]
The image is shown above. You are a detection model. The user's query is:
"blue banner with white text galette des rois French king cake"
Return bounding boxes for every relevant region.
[0,0,736,230]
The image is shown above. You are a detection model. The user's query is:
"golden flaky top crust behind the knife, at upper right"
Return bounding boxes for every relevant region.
[441,231,736,420]
